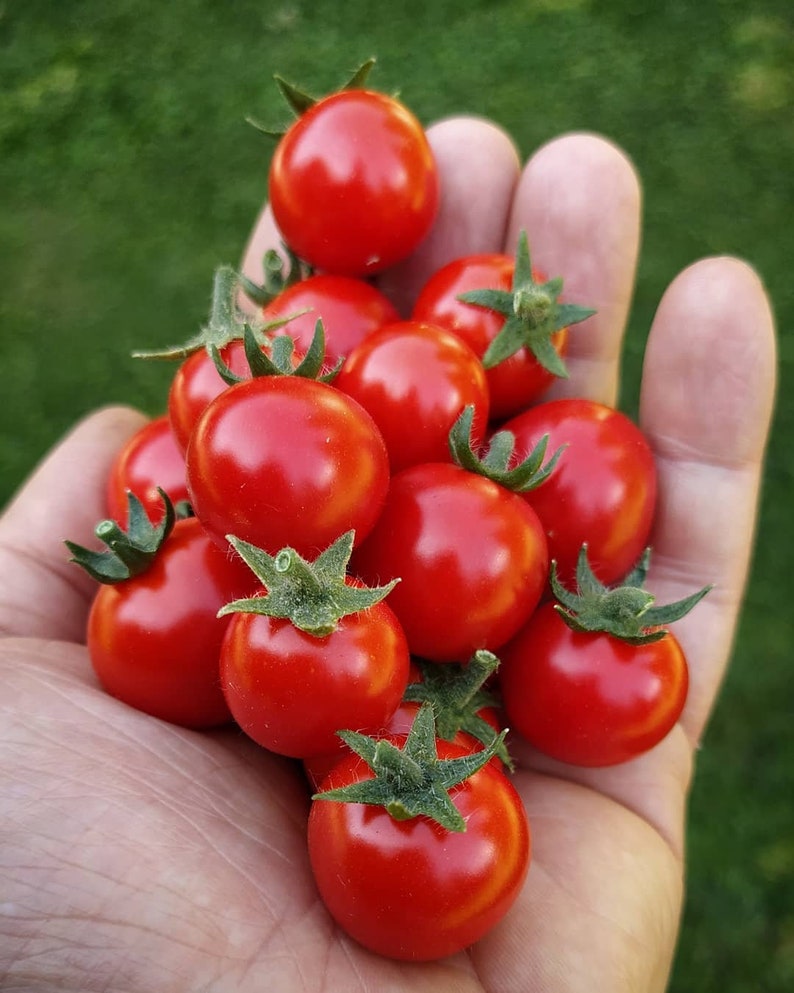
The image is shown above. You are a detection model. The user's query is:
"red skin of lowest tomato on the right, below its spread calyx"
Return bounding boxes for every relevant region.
[499,603,689,767]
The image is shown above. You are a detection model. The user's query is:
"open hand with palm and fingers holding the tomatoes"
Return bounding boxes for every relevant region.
[0,118,775,993]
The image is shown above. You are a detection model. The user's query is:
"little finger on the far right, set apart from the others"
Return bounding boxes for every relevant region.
[640,258,776,744]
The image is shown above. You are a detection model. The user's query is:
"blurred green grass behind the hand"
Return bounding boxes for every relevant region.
[0,0,794,993]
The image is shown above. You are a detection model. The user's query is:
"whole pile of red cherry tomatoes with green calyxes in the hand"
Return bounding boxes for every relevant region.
[70,62,702,959]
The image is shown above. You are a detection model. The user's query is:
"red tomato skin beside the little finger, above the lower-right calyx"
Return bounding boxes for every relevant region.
[503,399,657,586]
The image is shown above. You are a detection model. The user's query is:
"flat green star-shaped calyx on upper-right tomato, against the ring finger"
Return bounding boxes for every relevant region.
[458,231,595,378]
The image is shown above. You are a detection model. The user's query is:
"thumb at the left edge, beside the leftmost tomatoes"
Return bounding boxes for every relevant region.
[0,407,146,641]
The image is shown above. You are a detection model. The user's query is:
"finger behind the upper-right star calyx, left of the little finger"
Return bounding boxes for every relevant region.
[506,134,641,406]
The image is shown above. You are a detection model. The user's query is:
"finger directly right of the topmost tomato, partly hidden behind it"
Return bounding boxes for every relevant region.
[378,117,520,314]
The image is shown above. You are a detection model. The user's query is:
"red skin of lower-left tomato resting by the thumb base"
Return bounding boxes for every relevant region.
[87,518,256,728]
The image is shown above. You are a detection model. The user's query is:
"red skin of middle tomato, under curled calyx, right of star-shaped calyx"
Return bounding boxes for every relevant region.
[351,462,548,662]
